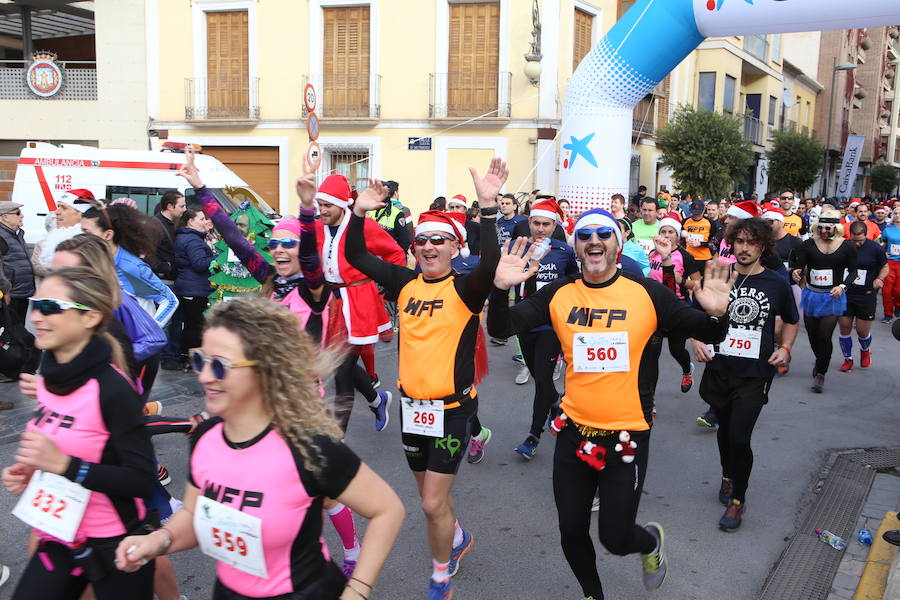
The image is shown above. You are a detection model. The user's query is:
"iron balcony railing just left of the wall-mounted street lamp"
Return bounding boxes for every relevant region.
[428,72,512,119]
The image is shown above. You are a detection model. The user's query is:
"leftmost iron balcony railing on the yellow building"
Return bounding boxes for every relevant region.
[184,77,259,121]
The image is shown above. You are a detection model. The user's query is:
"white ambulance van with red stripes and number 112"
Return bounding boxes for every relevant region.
[11,142,278,244]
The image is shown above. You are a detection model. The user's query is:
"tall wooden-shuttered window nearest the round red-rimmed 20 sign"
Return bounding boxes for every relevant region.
[322,5,369,117]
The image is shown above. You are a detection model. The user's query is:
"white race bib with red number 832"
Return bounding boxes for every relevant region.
[12,471,91,542]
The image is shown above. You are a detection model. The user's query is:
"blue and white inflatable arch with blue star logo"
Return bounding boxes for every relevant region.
[559,0,900,211]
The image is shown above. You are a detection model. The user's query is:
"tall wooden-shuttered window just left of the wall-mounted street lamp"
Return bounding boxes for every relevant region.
[447,2,500,117]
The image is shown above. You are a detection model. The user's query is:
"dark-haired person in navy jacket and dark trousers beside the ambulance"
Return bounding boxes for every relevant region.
[173,208,215,368]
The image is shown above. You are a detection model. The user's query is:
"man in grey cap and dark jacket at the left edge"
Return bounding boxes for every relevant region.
[0,201,34,324]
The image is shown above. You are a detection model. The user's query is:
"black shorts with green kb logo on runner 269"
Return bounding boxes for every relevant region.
[400,396,478,475]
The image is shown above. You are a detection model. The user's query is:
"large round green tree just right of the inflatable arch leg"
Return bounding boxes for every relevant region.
[656,106,753,198]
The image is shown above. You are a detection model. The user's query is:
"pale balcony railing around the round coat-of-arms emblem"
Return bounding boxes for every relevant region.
[0,60,97,101]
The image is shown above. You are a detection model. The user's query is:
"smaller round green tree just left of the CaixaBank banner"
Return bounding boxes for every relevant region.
[766,131,825,195]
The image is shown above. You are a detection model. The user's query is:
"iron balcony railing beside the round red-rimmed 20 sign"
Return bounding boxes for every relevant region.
[300,73,381,119]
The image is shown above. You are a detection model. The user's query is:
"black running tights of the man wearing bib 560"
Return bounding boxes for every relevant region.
[553,427,656,598]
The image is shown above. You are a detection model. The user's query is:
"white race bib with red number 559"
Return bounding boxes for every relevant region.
[194,496,269,579]
